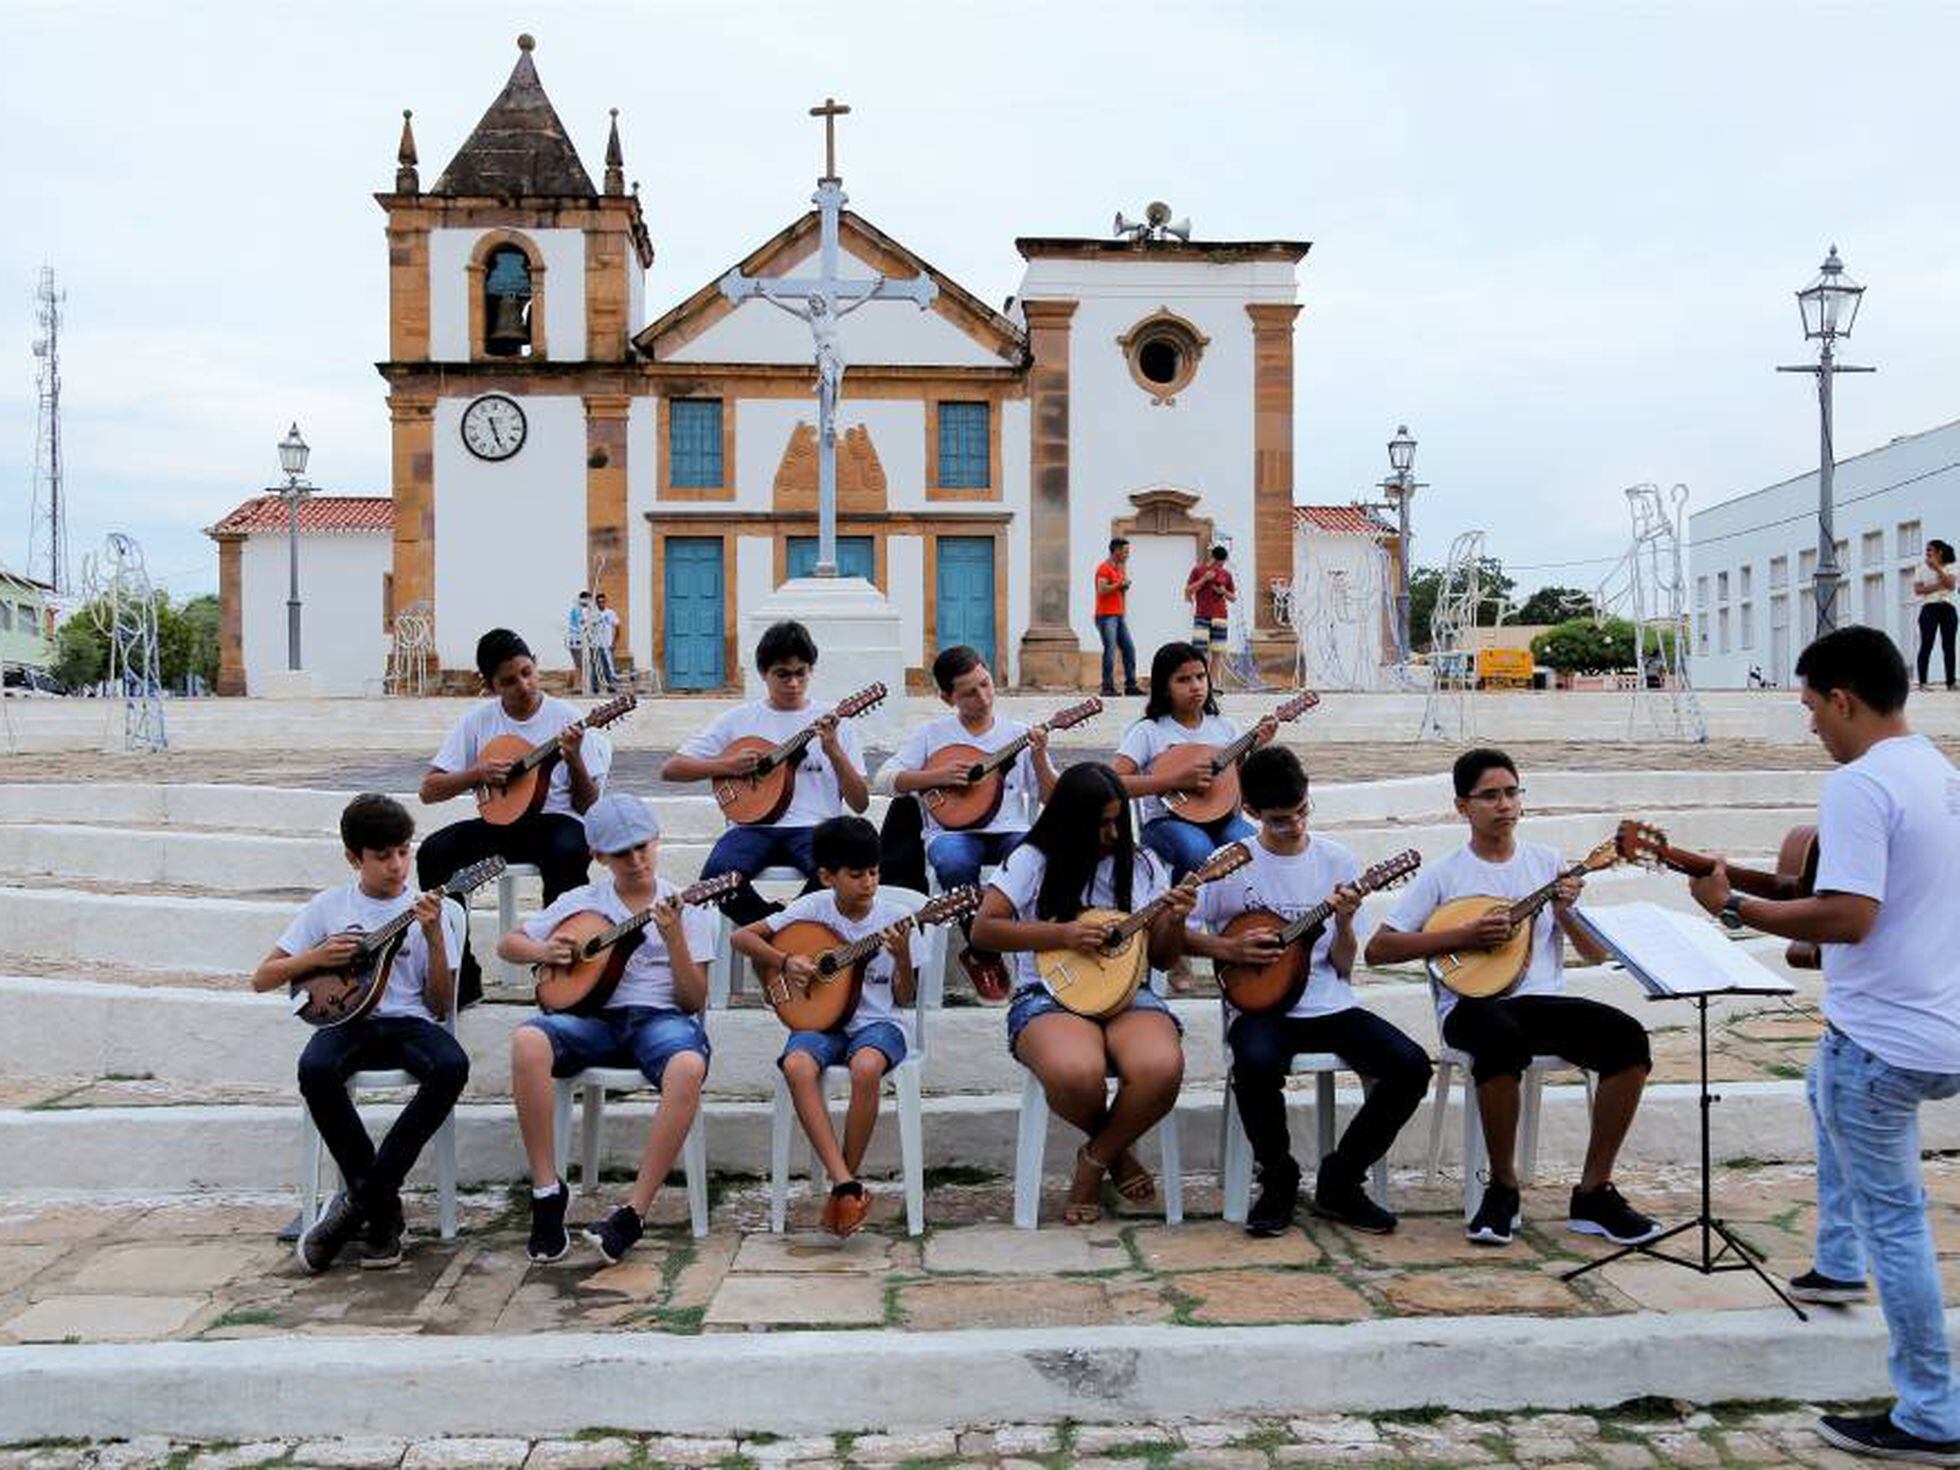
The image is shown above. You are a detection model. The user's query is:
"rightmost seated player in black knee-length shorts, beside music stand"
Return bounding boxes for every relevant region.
[1366,749,1660,1245]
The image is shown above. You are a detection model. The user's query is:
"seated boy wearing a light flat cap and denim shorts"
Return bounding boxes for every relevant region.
[496,794,715,1264]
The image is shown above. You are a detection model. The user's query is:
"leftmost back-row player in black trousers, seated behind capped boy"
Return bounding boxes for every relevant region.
[416,627,612,1005]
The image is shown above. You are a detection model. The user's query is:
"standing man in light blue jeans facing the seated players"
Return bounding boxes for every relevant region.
[1691,627,1960,1464]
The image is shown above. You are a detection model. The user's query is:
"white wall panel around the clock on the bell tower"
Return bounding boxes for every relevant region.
[435,394,586,668]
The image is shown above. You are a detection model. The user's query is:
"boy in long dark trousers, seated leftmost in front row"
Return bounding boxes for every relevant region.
[251,794,470,1272]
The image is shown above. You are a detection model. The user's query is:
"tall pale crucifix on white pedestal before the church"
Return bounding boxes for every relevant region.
[721,98,939,576]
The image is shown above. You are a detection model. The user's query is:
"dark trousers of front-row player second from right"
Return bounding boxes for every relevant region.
[1227,1005,1431,1182]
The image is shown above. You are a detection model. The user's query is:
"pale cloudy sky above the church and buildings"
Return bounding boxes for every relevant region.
[0,0,1960,596]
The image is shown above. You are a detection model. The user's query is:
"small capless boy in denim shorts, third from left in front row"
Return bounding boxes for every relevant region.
[733,817,915,1235]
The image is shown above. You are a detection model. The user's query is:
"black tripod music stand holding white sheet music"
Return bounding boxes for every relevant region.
[1560,904,1809,1321]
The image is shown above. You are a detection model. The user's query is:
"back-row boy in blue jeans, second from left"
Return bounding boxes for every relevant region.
[661,621,870,923]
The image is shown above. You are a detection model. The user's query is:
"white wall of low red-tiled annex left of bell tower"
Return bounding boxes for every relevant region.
[239,533,394,694]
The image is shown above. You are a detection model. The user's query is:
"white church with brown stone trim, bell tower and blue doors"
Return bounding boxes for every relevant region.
[214,35,1307,694]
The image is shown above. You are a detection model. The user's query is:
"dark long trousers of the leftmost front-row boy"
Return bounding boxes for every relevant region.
[300,1015,470,1213]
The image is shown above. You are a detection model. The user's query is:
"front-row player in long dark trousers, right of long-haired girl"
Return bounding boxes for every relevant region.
[1184,745,1429,1235]
